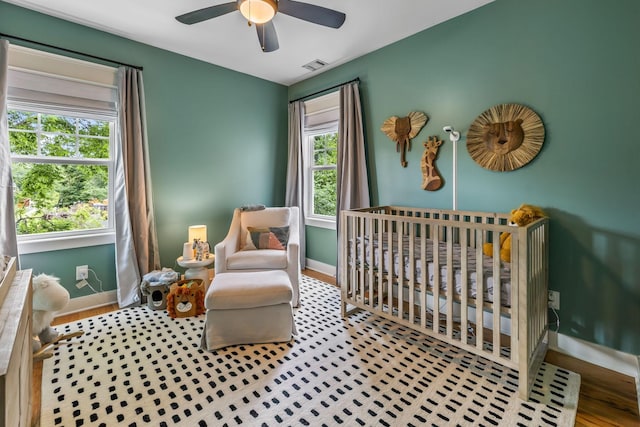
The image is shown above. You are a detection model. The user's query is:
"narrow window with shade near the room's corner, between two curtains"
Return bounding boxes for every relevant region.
[303,92,340,229]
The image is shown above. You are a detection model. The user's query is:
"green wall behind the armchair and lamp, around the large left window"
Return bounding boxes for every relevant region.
[0,2,287,296]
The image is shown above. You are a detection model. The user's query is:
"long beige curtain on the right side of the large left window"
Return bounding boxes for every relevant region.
[115,67,160,307]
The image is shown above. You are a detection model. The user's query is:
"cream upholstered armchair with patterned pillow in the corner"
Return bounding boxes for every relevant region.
[214,207,300,307]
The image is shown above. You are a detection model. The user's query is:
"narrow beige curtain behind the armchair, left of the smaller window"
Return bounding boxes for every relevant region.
[285,101,307,268]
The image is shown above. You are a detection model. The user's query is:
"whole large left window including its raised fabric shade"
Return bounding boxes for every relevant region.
[7,45,118,254]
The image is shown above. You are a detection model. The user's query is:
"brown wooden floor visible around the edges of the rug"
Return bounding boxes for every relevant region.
[32,270,640,427]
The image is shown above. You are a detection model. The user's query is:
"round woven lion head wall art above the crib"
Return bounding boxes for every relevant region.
[467,104,544,172]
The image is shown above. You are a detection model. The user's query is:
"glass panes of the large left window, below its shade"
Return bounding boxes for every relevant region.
[7,104,115,237]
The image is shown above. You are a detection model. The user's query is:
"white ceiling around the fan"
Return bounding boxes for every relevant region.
[4,0,493,86]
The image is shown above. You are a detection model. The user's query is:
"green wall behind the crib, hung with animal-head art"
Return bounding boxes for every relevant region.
[289,0,640,354]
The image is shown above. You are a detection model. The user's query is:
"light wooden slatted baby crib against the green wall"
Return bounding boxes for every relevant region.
[338,206,549,400]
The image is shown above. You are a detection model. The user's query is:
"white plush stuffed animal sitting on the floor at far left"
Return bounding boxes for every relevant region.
[31,274,83,360]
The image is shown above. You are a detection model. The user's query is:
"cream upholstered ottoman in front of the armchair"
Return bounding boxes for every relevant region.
[202,270,296,351]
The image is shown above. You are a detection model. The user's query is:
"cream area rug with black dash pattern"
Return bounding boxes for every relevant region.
[41,276,580,427]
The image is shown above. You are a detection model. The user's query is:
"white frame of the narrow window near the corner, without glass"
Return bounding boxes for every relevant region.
[303,121,338,230]
